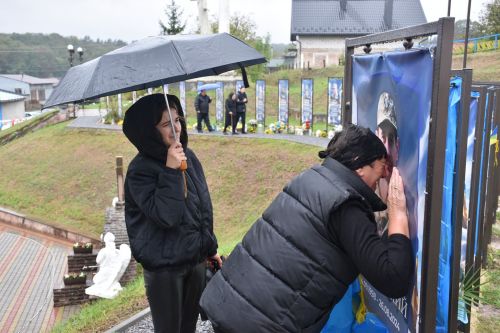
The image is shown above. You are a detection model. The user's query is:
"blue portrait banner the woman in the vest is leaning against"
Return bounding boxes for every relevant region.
[352,49,433,332]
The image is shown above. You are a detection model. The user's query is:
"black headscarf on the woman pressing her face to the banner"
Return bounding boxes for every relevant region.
[318,124,387,170]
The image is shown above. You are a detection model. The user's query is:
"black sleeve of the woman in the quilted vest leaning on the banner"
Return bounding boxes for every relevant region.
[328,200,415,298]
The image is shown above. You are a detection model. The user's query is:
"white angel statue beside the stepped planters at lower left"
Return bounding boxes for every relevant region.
[85,232,131,299]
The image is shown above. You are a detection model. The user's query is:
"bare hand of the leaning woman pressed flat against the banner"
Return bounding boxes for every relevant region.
[387,167,410,237]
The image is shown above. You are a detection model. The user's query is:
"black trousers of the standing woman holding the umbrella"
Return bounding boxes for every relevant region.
[144,262,205,333]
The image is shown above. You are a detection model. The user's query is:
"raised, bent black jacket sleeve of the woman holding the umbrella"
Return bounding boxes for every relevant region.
[127,167,186,228]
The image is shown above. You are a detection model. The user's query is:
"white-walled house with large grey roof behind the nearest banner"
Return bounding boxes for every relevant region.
[290,0,427,68]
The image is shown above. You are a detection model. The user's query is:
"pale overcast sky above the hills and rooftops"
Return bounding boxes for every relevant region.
[0,0,492,43]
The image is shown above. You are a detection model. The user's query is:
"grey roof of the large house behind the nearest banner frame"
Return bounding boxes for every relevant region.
[291,0,427,40]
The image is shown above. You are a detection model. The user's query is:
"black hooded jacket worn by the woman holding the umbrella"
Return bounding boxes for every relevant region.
[123,94,217,271]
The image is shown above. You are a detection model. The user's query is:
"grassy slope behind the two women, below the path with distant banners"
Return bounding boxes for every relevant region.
[0,120,319,245]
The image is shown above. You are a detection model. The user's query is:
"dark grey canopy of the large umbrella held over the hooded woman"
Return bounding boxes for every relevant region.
[43,33,266,108]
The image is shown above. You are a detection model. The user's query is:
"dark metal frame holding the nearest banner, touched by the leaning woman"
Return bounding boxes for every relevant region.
[342,17,455,332]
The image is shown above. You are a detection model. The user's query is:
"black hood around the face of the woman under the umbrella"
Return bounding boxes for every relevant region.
[123,94,188,163]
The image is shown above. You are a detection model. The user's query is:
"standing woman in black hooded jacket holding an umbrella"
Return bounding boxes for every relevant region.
[123,94,222,333]
